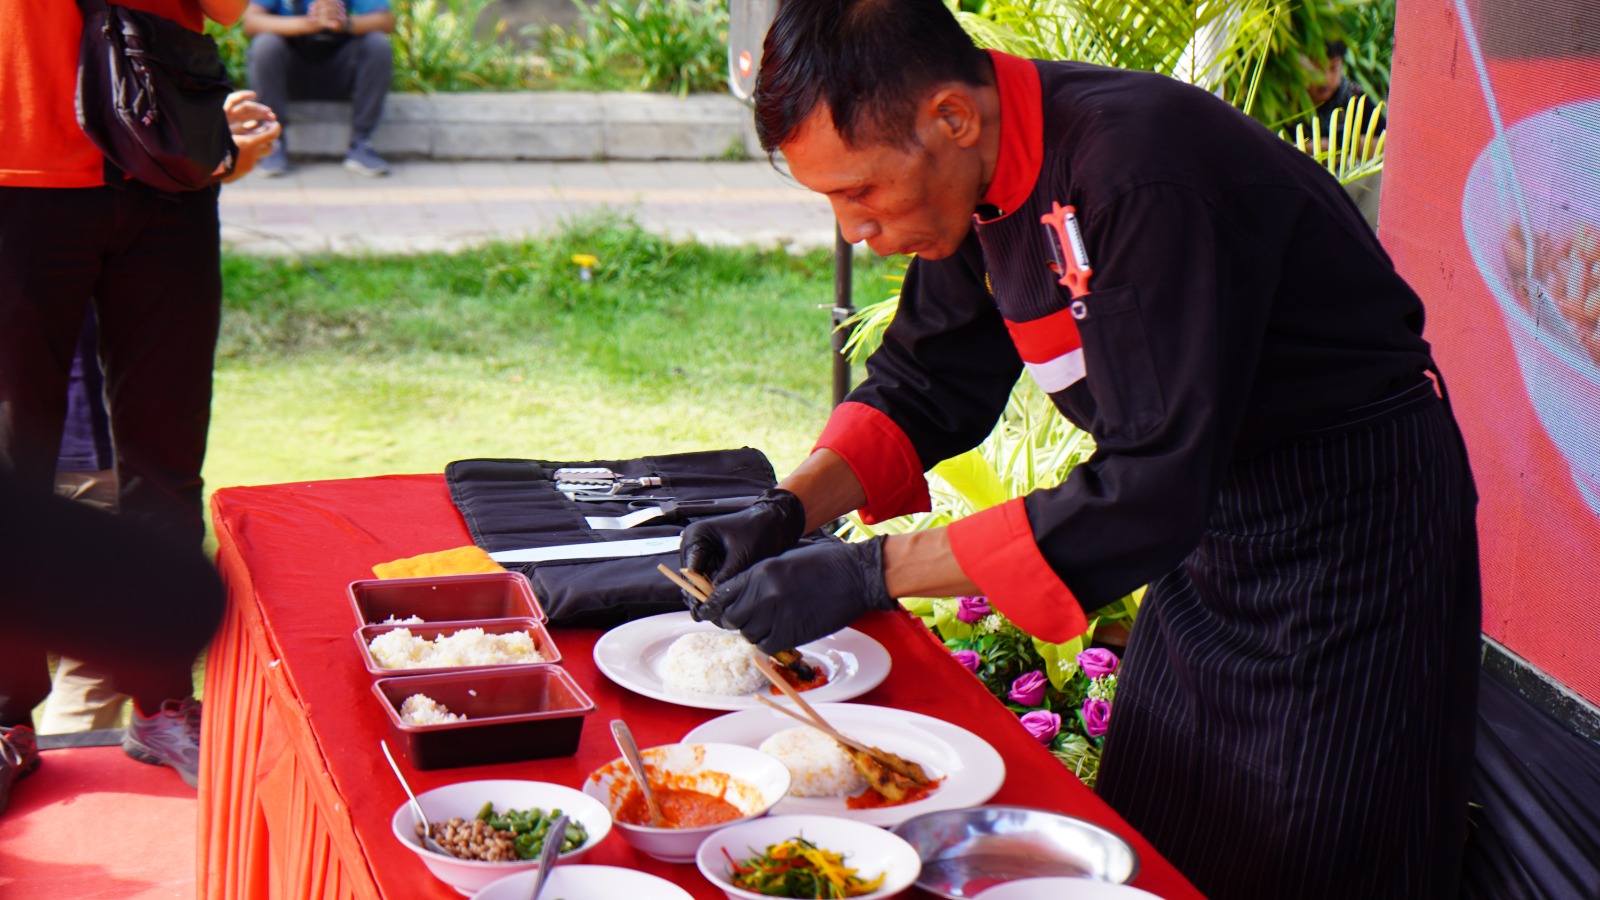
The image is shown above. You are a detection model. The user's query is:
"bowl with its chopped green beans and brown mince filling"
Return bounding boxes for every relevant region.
[389,780,611,897]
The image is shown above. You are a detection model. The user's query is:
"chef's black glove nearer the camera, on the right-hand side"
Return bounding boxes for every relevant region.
[699,535,896,653]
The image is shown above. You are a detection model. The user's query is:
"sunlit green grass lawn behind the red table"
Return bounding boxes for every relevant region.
[205,219,902,490]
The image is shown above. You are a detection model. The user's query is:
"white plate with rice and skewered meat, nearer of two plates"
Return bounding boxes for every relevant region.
[683,703,1005,828]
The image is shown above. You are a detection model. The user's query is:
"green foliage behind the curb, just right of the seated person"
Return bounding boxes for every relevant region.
[394,0,526,93]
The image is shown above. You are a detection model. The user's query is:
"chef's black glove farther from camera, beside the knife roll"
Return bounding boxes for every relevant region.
[678,487,805,592]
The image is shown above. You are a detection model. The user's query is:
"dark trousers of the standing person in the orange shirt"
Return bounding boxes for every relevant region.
[0,183,222,721]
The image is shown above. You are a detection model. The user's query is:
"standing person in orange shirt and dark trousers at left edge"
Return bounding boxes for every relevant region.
[0,0,278,785]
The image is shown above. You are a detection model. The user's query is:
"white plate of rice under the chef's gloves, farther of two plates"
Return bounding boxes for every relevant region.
[595,610,890,709]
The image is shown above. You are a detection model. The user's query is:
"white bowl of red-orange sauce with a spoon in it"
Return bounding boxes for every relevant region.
[584,743,790,863]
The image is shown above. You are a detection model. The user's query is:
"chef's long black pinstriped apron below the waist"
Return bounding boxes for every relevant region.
[1099,399,1482,900]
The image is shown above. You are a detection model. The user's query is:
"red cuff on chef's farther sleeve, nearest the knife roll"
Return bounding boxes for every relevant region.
[811,402,933,525]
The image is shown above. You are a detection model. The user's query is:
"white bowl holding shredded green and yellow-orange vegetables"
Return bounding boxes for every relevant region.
[694,815,922,900]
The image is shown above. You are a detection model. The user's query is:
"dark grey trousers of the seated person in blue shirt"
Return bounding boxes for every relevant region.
[248,32,394,141]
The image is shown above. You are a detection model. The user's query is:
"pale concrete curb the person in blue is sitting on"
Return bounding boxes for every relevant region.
[283,91,763,160]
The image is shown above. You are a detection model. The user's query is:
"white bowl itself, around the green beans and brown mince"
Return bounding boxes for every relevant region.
[389,780,611,897]
